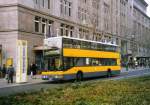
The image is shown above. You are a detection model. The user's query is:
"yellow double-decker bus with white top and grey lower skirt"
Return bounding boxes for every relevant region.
[42,36,121,80]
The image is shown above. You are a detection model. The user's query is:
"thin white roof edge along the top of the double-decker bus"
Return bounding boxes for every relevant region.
[47,36,118,47]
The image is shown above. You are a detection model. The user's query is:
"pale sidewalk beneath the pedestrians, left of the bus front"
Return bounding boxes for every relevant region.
[0,75,47,88]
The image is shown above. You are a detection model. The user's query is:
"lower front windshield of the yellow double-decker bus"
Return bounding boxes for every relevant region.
[44,55,63,71]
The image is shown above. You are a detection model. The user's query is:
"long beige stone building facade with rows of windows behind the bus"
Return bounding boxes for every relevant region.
[0,0,150,68]
